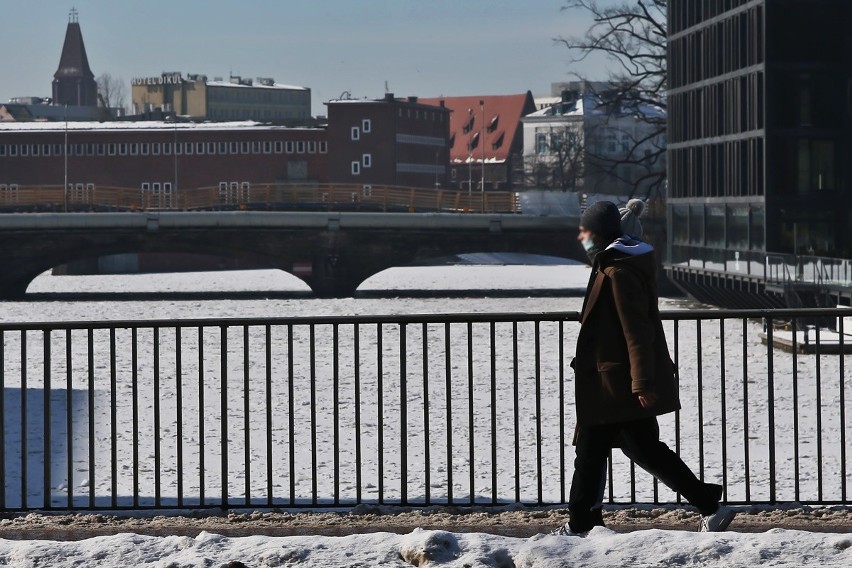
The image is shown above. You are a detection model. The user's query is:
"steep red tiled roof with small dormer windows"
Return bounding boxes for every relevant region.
[419,91,535,163]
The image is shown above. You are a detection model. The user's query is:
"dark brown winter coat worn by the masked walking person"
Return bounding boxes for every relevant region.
[571,237,680,426]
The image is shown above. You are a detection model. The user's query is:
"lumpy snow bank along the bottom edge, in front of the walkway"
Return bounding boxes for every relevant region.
[0,527,852,568]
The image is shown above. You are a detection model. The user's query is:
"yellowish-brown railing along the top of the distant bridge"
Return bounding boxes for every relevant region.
[0,182,521,213]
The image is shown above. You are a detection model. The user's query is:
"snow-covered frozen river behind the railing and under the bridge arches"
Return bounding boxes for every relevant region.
[2,266,848,507]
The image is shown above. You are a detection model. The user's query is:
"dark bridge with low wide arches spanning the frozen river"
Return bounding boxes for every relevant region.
[0,211,585,299]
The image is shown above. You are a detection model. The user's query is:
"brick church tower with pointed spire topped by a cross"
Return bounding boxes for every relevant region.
[53,8,98,106]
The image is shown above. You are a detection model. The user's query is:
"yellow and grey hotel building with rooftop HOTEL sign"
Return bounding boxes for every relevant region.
[131,73,311,122]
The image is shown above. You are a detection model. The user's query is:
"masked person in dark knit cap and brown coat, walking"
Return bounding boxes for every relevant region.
[562,201,734,533]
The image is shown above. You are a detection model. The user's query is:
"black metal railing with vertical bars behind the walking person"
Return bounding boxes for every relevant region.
[0,309,852,511]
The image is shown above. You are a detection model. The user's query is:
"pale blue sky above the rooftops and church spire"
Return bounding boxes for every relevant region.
[0,0,606,114]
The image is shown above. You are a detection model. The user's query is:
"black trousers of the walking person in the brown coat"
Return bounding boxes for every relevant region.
[568,418,718,532]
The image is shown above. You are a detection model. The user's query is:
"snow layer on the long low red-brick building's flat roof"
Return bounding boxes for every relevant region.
[0,120,317,133]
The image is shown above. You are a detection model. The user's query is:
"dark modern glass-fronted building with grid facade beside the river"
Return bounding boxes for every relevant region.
[664,0,852,307]
